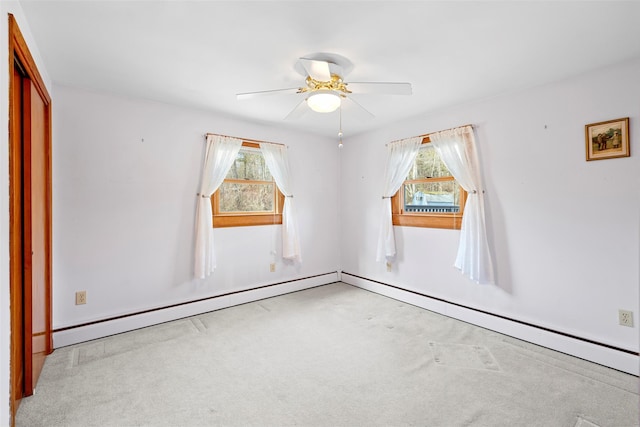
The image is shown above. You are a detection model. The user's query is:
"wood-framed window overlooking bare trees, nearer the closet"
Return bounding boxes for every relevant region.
[211,142,284,227]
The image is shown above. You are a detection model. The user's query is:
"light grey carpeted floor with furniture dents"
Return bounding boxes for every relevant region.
[17,283,639,427]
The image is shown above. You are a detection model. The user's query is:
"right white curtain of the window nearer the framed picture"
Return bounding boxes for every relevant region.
[429,126,494,284]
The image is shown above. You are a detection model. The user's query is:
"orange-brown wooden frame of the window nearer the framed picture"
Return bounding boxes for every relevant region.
[391,136,467,230]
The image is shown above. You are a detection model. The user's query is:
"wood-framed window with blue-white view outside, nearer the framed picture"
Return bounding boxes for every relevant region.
[391,137,467,229]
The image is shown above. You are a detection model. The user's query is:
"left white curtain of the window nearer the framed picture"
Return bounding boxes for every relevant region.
[376,137,422,262]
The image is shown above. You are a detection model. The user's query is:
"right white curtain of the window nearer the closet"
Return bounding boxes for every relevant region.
[260,142,302,262]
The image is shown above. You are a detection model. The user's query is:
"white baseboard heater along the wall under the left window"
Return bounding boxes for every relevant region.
[53,271,339,348]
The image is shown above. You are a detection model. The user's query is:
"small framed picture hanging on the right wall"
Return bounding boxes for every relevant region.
[584,117,630,161]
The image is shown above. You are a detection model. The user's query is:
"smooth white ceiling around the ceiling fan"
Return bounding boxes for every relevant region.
[21,0,640,138]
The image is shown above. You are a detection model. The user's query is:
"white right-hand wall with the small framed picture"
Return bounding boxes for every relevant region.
[341,61,640,360]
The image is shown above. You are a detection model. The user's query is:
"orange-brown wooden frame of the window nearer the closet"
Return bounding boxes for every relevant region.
[211,141,284,228]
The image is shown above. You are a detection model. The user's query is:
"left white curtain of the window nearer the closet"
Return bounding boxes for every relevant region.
[194,135,242,279]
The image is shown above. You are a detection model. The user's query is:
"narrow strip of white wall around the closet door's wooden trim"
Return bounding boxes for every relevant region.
[0,1,53,426]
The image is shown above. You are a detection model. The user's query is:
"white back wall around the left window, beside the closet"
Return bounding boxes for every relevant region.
[53,86,339,329]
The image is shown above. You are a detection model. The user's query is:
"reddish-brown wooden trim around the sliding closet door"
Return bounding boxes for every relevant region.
[7,14,53,425]
